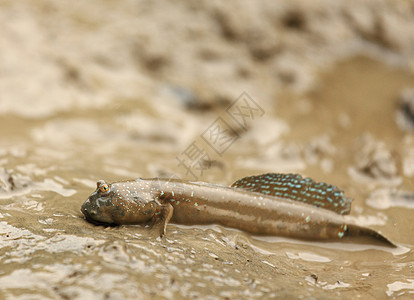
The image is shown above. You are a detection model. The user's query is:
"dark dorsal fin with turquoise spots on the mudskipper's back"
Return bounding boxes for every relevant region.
[231,173,352,215]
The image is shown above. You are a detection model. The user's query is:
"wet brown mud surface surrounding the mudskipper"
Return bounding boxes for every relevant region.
[0,0,414,299]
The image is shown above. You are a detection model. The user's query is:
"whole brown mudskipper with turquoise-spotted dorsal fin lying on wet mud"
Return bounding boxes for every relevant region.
[81,173,395,247]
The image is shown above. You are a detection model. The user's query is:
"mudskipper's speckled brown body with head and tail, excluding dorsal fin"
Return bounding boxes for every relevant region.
[81,179,392,245]
